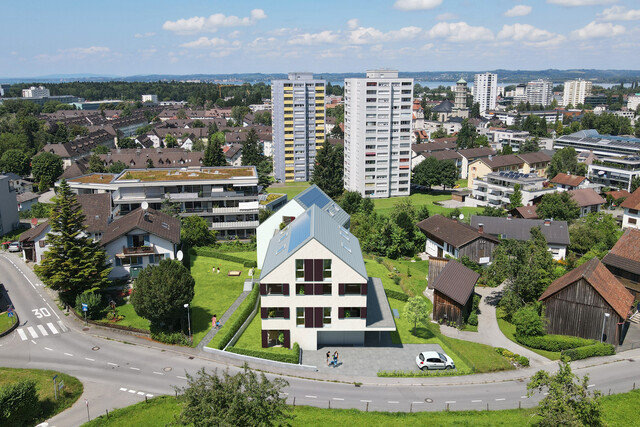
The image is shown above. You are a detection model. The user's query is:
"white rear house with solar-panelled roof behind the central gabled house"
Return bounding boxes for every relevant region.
[256,184,351,268]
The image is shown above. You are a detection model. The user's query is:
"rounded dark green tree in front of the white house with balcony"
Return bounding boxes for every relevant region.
[131,259,195,329]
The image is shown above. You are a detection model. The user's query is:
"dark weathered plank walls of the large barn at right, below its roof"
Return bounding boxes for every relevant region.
[545,278,624,345]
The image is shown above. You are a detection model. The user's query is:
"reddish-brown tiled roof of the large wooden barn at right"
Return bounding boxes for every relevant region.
[538,258,633,319]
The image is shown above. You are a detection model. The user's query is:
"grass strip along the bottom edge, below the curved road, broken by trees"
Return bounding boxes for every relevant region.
[83,390,640,427]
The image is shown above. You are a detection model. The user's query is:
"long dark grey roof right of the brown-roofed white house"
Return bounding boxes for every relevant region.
[471,215,569,245]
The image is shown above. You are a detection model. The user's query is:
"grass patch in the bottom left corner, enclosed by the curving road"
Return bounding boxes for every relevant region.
[0,368,83,425]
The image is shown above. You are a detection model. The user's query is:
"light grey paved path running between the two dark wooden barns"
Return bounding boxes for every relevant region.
[425,284,555,367]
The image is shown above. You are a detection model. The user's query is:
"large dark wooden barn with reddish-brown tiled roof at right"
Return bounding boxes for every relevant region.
[540,258,633,346]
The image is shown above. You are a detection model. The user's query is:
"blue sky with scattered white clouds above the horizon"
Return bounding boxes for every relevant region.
[0,0,640,77]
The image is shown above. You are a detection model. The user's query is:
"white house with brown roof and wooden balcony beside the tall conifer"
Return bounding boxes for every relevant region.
[100,208,180,279]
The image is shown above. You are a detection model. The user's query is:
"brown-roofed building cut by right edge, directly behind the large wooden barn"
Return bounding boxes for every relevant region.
[602,228,640,300]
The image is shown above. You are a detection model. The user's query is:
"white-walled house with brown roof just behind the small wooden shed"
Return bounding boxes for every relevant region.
[416,215,500,264]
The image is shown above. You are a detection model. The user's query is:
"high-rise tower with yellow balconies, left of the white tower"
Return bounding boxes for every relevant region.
[271,73,325,181]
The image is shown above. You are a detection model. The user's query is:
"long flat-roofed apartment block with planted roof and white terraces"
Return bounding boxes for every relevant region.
[68,166,259,239]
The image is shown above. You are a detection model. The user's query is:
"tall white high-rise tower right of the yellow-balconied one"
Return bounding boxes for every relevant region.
[344,70,413,198]
